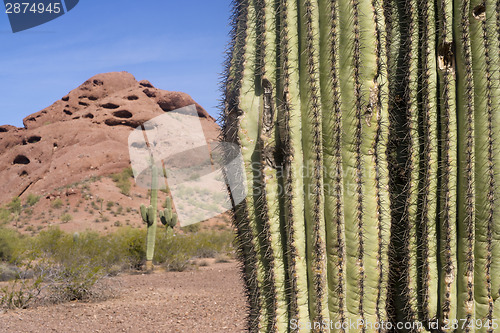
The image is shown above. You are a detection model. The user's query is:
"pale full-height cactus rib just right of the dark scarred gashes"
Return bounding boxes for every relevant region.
[278,0,309,331]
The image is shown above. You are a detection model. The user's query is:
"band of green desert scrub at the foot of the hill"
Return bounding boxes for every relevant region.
[0,227,233,309]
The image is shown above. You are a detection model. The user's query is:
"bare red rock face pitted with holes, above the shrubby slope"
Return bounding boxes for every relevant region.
[0,72,219,204]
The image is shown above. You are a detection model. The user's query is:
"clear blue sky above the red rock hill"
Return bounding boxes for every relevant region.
[0,0,231,127]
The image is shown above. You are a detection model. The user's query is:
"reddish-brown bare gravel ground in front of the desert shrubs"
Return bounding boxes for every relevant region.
[0,262,246,333]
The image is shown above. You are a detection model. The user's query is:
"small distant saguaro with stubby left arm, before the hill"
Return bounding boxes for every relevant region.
[140,163,158,271]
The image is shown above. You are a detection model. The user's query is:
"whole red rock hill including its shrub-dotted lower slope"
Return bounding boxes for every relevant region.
[0,72,227,230]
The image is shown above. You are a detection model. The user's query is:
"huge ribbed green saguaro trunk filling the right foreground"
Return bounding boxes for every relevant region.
[223,0,500,332]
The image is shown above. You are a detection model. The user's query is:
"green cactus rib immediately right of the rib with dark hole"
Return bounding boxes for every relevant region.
[454,0,475,331]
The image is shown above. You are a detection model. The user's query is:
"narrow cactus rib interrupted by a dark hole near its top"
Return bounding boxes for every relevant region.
[436,0,457,330]
